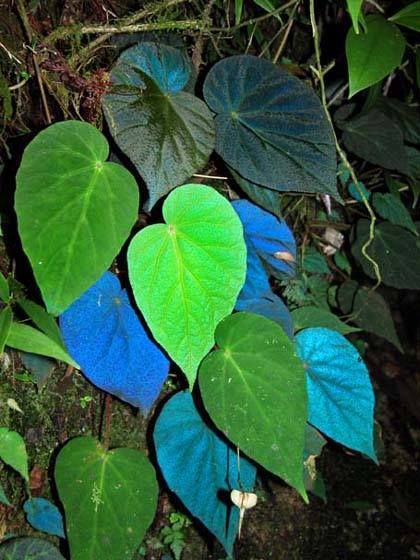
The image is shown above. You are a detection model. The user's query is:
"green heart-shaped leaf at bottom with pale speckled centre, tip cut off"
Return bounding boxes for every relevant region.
[54,437,158,560]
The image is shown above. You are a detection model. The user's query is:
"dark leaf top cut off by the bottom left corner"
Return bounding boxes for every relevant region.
[0,537,64,560]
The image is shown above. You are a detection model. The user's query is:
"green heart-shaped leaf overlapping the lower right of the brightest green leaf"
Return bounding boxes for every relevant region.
[199,313,307,499]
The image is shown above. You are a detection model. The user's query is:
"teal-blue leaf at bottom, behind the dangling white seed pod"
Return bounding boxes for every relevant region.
[153,392,256,554]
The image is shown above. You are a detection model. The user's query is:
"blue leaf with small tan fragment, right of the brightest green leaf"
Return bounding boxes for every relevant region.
[232,200,296,299]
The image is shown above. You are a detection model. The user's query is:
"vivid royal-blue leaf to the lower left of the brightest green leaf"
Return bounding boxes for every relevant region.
[60,272,169,413]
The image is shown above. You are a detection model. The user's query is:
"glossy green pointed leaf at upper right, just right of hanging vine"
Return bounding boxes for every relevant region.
[346,15,406,97]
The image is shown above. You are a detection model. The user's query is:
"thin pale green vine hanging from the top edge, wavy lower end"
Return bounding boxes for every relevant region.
[309,0,382,291]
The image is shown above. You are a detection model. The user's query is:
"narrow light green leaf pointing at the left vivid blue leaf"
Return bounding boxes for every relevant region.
[6,322,79,368]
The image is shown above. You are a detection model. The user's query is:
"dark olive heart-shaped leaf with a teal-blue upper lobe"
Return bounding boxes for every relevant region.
[103,43,215,209]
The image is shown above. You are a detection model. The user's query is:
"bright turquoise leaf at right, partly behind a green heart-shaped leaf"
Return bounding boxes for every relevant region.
[296,328,377,461]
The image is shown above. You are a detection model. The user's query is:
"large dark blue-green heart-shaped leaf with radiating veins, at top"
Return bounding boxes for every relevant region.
[204,55,340,199]
